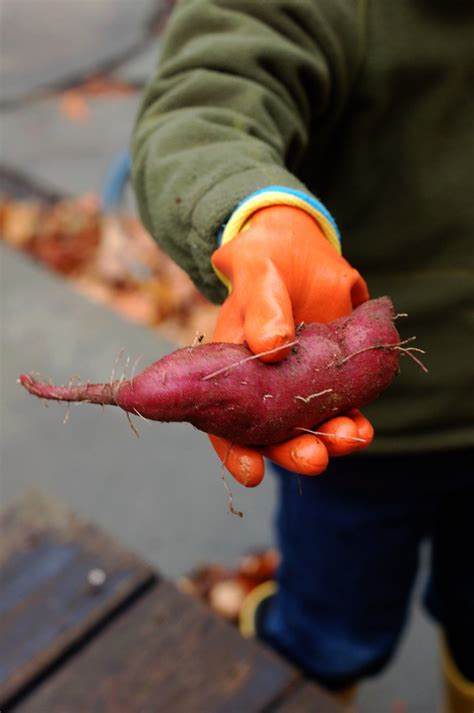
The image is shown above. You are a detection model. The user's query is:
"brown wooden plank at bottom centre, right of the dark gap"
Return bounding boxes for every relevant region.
[18,582,298,713]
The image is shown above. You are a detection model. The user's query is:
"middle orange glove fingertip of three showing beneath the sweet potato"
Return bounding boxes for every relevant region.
[262,433,329,475]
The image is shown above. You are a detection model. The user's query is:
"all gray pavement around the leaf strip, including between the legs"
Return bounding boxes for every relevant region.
[0,0,439,713]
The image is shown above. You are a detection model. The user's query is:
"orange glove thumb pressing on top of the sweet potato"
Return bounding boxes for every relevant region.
[244,261,295,362]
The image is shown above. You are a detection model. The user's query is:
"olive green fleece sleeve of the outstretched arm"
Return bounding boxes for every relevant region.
[132,0,362,302]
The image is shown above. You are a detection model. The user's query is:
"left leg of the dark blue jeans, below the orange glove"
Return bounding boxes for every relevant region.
[259,458,431,688]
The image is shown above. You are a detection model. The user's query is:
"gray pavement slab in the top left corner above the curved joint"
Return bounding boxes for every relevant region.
[0,0,160,102]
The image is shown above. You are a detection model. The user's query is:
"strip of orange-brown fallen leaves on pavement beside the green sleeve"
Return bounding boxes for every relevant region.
[0,194,217,345]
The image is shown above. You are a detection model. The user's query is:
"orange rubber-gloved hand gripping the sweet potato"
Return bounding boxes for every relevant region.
[209,205,373,486]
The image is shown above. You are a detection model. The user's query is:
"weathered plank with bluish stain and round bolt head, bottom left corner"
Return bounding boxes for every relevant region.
[0,492,155,708]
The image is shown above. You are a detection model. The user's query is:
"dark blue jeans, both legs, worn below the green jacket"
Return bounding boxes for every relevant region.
[257,451,474,689]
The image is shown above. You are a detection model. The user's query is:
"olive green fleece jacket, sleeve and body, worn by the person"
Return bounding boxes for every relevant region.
[132,0,474,453]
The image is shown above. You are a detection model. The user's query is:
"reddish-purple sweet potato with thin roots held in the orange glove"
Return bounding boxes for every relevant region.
[20,297,403,446]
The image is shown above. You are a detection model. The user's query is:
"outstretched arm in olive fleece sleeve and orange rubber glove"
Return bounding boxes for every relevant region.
[133,0,372,484]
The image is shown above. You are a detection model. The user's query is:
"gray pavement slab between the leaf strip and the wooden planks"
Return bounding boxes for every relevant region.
[1,247,274,577]
